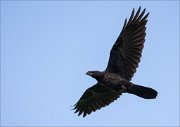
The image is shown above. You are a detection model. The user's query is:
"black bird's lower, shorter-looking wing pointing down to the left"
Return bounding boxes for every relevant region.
[74,83,120,117]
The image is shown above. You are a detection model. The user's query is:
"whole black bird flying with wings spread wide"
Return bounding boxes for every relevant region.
[74,7,158,117]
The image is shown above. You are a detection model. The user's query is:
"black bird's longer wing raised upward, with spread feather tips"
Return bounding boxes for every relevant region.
[106,7,149,80]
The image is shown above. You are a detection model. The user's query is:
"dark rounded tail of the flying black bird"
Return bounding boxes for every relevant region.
[127,84,158,99]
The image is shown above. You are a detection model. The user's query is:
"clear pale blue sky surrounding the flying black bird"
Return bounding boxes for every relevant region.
[1,1,179,126]
